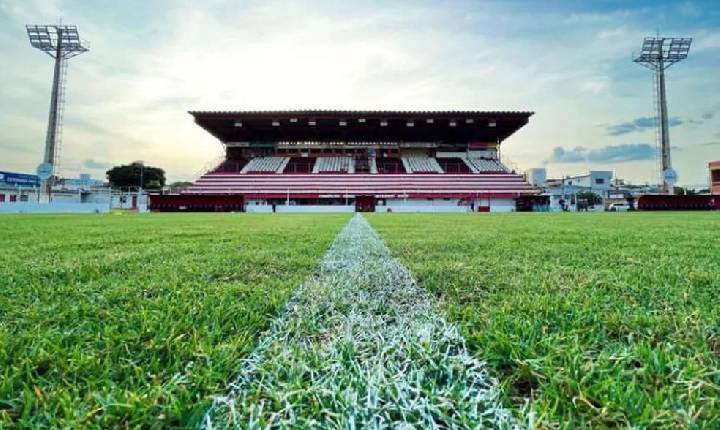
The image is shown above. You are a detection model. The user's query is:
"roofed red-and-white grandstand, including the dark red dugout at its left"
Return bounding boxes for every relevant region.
[151,110,537,212]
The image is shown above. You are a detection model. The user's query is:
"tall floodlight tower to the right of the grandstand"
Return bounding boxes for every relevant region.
[633,36,692,194]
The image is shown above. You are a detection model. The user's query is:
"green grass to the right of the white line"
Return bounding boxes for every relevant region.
[368,213,720,428]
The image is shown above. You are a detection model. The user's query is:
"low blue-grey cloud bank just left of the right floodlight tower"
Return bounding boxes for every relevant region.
[545,143,656,164]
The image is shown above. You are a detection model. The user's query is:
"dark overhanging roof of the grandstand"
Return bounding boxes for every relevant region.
[189,110,533,143]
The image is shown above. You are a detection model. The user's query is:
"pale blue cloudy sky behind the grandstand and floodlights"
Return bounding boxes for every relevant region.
[0,0,720,186]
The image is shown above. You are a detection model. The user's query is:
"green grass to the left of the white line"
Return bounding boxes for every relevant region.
[0,214,349,428]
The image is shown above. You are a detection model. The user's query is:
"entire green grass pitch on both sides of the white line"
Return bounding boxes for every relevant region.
[0,213,720,428]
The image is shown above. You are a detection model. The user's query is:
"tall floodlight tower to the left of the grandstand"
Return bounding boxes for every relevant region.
[25,24,88,201]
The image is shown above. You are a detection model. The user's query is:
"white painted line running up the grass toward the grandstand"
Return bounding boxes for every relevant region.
[201,215,520,429]
